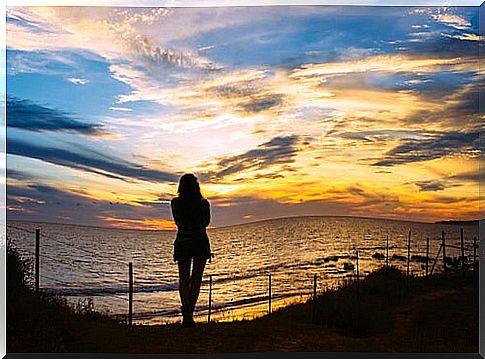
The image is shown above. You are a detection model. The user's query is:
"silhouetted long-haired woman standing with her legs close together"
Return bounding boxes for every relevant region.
[171,173,211,327]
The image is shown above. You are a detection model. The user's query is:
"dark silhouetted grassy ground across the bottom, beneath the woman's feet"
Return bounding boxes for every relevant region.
[7,240,478,354]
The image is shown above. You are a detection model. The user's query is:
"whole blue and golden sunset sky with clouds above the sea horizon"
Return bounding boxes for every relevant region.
[7,6,483,229]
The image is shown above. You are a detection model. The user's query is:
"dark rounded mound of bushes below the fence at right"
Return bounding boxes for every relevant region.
[316,267,478,345]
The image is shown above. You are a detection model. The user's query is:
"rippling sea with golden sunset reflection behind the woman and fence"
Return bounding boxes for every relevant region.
[7,217,478,324]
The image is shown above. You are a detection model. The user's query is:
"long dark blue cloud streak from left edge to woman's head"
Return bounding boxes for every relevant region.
[7,138,178,182]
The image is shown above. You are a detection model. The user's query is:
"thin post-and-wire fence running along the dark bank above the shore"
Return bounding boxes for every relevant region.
[7,225,478,325]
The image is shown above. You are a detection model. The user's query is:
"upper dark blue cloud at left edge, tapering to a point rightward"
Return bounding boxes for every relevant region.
[7,96,106,136]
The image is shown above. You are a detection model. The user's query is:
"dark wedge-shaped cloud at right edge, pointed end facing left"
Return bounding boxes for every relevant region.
[374,132,480,167]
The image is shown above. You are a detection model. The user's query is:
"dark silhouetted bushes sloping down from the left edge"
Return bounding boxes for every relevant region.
[6,241,125,352]
